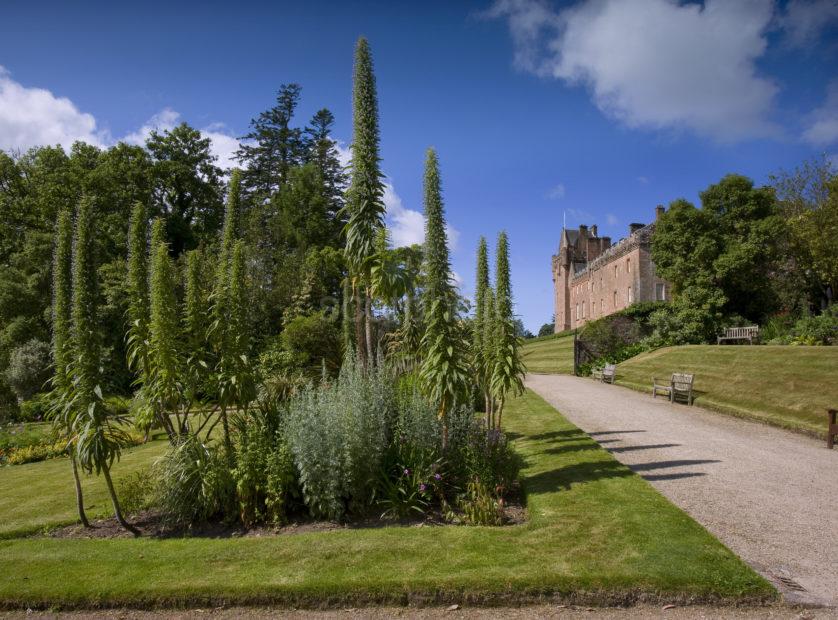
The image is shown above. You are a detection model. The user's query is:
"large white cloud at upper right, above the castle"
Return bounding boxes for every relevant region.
[489,0,778,142]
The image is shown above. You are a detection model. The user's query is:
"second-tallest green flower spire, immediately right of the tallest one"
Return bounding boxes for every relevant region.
[419,149,469,448]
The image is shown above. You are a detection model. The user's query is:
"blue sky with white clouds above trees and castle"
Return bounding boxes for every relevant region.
[0,0,838,331]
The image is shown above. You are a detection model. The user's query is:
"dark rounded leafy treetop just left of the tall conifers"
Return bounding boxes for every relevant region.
[146,123,222,256]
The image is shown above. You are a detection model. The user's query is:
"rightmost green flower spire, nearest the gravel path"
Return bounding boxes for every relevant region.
[492,232,526,428]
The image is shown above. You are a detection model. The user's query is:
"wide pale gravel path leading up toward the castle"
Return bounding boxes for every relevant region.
[526,375,838,607]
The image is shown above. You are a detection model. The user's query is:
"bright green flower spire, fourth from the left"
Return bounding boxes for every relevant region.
[148,219,186,444]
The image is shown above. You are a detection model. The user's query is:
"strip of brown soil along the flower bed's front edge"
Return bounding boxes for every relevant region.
[37,504,527,538]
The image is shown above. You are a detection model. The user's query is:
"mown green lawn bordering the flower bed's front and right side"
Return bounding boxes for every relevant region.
[0,392,775,606]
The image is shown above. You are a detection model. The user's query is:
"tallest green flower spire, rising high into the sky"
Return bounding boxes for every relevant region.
[345,37,385,358]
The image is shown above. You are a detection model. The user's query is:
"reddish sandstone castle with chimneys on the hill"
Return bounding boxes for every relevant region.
[553,206,670,333]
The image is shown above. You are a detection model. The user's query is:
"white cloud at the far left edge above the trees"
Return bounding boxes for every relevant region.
[0,66,108,150]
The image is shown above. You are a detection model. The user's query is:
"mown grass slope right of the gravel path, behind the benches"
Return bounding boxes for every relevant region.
[617,345,838,434]
